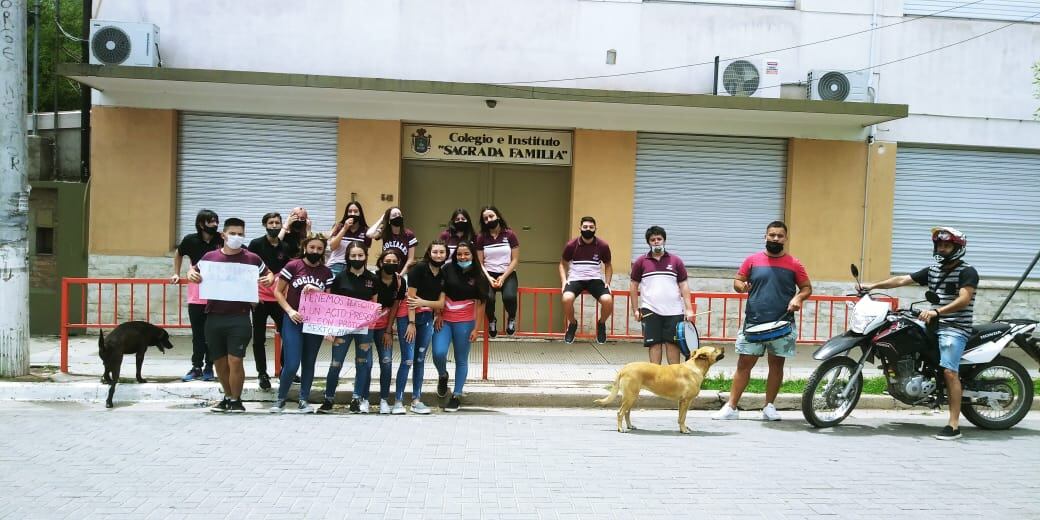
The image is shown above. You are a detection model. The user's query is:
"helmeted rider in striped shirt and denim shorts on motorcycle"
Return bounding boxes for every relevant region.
[862,226,979,441]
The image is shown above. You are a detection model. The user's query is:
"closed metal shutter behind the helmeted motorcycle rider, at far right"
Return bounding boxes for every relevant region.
[892,145,1040,278]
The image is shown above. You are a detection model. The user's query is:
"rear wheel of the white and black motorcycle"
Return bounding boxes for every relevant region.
[961,356,1033,430]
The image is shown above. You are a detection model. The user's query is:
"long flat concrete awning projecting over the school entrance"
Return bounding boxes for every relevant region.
[58,63,908,140]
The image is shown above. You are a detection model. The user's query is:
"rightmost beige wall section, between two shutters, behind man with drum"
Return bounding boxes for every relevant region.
[785,139,895,281]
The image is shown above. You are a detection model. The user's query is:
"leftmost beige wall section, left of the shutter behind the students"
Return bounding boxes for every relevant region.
[89,106,177,256]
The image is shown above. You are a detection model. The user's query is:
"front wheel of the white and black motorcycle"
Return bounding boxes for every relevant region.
[802,356,863,427]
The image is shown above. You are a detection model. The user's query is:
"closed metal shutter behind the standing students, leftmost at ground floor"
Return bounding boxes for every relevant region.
[177,112,338,239]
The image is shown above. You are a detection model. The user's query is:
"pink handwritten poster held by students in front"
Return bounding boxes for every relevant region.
[300,291,380,336]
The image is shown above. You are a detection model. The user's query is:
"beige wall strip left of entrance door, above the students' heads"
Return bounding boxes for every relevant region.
[336,120,400,229]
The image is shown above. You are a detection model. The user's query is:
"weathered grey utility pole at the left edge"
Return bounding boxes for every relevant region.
[0,0,29,376]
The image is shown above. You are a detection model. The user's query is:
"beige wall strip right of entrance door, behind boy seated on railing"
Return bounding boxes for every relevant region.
[569,129,635,266]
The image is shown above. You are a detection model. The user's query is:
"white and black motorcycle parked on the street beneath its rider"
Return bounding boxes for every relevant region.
[802,265,1040,430]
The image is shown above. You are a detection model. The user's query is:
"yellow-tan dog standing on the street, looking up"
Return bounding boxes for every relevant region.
[596,346,724,434]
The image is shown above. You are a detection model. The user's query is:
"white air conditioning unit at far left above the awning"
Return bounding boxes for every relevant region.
[90,20,159,67]
